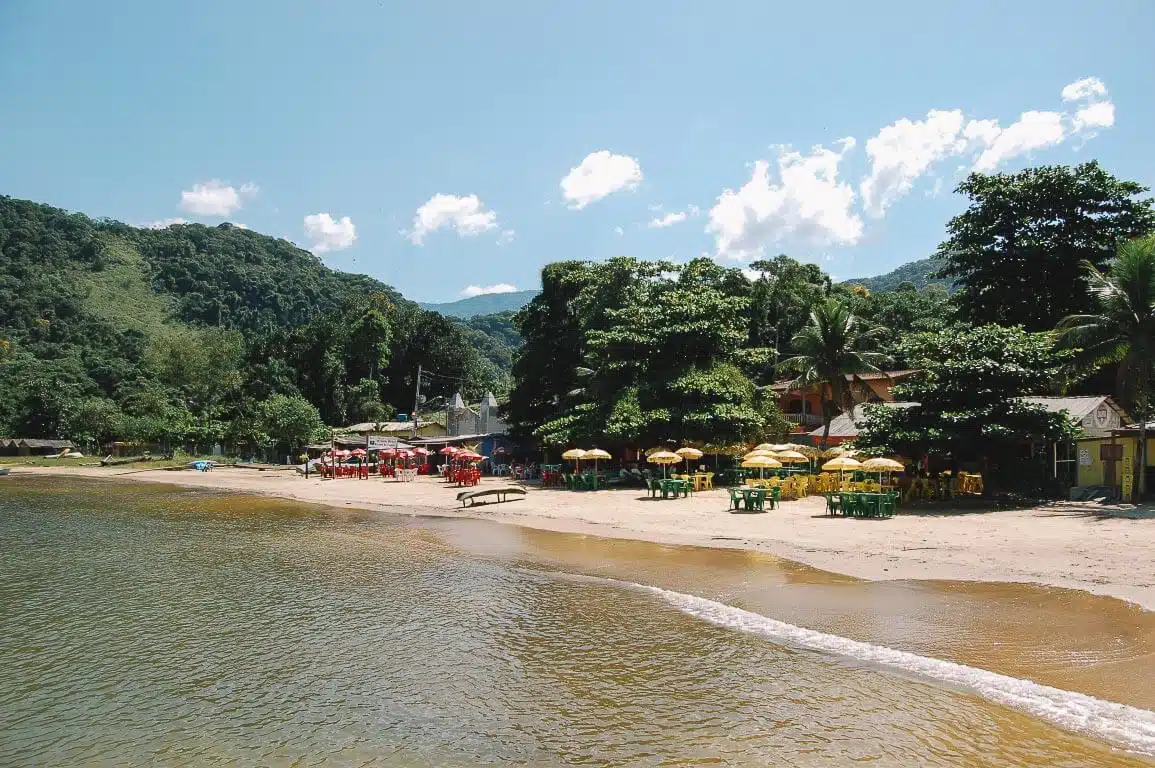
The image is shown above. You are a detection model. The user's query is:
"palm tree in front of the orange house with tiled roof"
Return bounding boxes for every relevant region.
[780,298,891,448]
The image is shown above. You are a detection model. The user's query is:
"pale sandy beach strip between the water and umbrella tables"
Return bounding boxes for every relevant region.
[12,467,1155,610]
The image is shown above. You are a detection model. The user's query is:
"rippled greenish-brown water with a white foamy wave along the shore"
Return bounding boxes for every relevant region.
[0,477,1155,766]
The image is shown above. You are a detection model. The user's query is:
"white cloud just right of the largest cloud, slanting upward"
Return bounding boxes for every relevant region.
[858,110,966,216]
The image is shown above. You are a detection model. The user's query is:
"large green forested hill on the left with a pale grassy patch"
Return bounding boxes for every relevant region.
[0,196,511,441]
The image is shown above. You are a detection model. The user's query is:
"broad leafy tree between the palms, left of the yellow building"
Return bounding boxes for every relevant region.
[855,325,1076,490]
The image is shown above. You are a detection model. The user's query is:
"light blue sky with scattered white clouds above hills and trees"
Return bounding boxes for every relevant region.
[0,0,1155,300]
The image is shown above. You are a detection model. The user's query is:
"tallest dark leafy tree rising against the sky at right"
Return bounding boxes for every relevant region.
[938,162,1155,330]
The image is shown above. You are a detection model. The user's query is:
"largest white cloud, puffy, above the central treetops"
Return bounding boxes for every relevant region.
[706,137,863,259]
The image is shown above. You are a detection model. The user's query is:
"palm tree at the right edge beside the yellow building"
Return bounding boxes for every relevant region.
[1056,236,1155,497]
